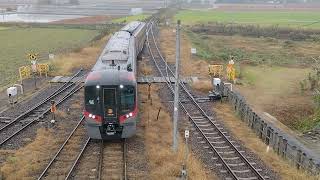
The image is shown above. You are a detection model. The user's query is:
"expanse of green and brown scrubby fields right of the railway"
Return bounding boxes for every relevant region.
[175,10,320,132]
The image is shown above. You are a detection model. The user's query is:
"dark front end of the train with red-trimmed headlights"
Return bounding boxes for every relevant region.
[84,71,138,140]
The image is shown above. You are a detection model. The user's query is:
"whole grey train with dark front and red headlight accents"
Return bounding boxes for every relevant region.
[84,22,146,140]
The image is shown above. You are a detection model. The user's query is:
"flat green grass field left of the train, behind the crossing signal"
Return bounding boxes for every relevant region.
[0,28,100,87]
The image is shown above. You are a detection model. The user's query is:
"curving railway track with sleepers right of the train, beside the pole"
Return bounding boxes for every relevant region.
[147,23,269,180]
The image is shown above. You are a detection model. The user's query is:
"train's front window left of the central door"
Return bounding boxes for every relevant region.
[84,86,99,114]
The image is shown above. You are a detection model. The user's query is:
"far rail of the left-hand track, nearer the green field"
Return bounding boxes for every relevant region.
[0,69,82,132]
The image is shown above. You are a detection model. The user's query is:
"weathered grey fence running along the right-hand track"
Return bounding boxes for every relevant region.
[222,82,320,174]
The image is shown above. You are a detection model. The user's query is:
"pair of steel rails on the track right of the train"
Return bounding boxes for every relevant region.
[147,22,264,179]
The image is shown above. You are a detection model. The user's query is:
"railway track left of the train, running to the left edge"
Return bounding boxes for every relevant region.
[0,70,83,148]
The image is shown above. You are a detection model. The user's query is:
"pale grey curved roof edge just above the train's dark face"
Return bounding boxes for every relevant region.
[85,70,136,86]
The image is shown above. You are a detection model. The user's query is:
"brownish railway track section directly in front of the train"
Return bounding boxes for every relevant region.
[63,140,127,180]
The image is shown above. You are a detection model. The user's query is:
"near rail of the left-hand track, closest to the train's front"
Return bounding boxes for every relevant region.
[0,85,83,147]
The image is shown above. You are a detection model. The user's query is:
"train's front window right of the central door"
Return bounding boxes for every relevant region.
[120,86,135,115]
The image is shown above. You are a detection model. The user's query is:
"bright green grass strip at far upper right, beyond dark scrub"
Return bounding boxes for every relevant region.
[175,10,320,29]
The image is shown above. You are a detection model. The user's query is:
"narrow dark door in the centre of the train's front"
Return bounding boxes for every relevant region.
[103,88,118,121]
